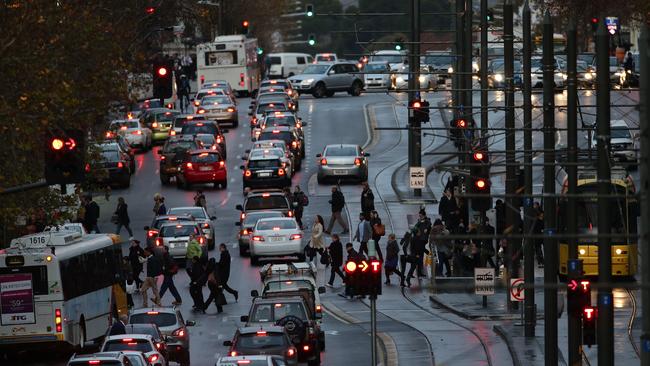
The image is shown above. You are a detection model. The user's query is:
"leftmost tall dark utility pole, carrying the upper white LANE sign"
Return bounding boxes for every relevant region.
[408,0,422,197]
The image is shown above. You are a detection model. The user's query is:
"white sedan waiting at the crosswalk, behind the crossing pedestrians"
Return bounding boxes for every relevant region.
[250,217,305,265]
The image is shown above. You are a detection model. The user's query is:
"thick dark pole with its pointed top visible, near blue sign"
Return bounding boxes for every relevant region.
[596,16,614,366]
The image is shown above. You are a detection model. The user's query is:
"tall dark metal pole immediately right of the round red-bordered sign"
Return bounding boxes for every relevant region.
[522,0,536,337]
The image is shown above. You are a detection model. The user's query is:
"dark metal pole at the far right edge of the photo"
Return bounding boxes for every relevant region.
[639,25,650,366]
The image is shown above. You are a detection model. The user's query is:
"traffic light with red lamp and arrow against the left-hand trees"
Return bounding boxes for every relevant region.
[44,130,86,185]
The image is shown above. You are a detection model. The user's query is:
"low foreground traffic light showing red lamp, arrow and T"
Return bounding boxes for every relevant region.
[345,259,382,296]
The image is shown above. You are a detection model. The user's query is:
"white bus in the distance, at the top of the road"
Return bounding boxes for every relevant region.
[196,35,260,95]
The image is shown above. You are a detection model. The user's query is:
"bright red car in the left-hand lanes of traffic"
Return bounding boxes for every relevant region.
[176,149,228,189]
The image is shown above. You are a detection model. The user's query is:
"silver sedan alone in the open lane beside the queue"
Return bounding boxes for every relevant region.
[316,144,370,184]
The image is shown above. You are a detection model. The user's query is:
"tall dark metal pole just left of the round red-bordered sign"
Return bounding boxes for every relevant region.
[503,0,519,310]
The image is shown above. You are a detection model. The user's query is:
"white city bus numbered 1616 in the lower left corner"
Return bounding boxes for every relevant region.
[0,230,127,351]
